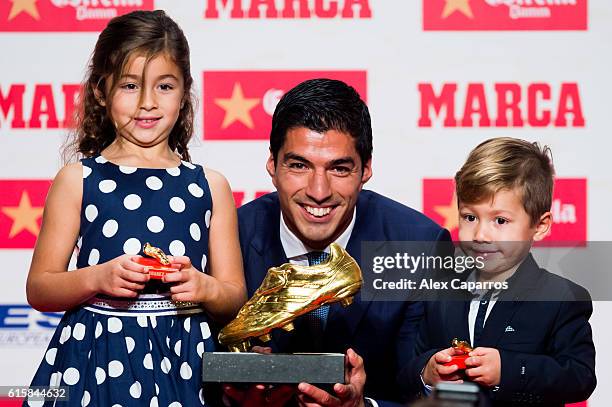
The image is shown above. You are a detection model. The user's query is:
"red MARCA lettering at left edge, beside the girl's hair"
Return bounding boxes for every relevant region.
[0,83,81,129]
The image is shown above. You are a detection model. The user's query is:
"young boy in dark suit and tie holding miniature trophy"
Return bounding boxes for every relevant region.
[399,138,596,406]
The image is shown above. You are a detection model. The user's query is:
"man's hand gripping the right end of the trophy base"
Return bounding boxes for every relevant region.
[298,349,366,407]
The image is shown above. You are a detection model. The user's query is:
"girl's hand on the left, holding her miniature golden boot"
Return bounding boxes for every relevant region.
[94,254,149,298]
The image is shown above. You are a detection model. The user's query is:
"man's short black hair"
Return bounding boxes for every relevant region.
[270,79,372,165]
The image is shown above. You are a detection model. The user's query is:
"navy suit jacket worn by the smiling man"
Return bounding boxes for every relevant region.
[238,191,450,405]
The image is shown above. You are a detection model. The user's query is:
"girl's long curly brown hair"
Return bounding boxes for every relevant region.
[63,10,195,162]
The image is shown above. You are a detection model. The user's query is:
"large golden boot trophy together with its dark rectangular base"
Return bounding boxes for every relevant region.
[202,244,362,386]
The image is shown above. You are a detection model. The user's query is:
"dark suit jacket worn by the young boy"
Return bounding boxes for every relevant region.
[399,255,596,406]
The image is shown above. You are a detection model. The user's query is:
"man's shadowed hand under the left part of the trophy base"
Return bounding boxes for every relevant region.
[223,346,295,407]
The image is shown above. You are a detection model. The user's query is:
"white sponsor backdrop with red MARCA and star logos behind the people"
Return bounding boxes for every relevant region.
[0,0,612,407]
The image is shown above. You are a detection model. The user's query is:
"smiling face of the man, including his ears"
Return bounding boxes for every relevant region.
[266,127,372,249]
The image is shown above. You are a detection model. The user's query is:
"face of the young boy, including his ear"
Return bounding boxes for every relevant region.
[459,189,551,277]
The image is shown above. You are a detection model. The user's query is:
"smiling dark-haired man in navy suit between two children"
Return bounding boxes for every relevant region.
[238,79,450,406]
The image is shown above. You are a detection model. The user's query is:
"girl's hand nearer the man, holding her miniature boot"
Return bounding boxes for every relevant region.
[162,256,214,302]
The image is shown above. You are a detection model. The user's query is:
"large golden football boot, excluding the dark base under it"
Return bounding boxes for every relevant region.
[219,243,362,352]
